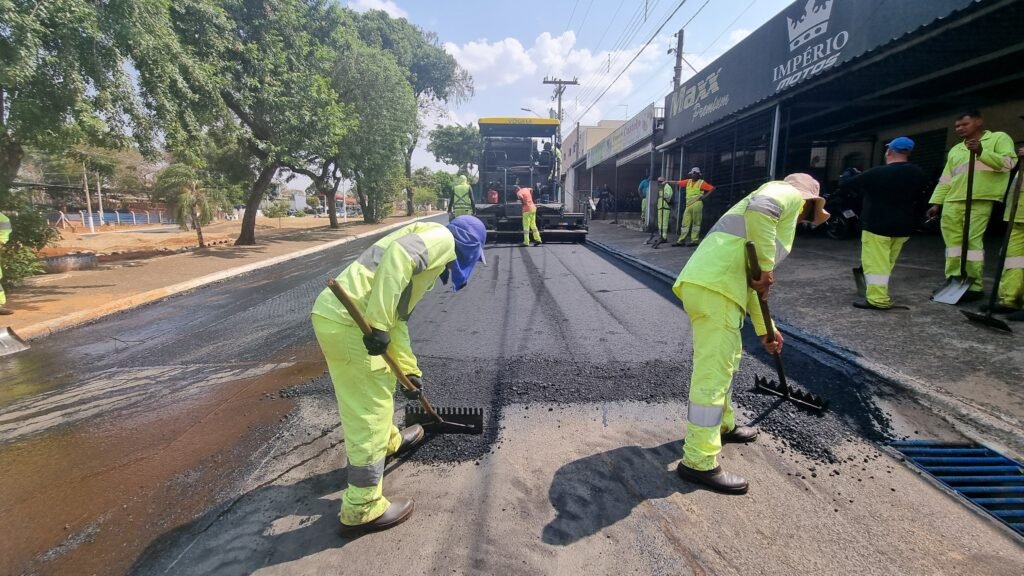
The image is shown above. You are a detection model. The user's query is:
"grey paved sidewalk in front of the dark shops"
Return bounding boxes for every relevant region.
[588,221,1024,456]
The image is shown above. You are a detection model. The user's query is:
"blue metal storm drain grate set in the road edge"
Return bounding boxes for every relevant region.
[890,440,1024,536]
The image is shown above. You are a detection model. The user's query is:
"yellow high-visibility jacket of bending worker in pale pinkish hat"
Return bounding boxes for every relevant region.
[672,181,804,335]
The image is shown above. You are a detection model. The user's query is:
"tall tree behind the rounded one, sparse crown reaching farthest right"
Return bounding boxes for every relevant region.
[356,10,473,216]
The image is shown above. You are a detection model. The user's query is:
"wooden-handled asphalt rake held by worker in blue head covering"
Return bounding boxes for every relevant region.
[327,278,483,435]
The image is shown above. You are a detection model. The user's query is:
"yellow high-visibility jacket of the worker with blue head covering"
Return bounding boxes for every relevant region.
[312,222,456,374]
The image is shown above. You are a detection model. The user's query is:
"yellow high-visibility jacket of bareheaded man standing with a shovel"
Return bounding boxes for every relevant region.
[929,130,1017,204]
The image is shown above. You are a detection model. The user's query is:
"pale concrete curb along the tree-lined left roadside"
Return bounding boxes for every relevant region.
[17,214,437,340]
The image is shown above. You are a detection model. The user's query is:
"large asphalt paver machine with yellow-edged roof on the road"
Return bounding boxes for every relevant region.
[474,118,589,242]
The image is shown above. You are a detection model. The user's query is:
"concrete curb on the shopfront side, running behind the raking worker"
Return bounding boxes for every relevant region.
[587,238,1024,455]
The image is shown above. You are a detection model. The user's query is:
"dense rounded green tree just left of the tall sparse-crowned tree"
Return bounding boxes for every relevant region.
[328,43,416,222]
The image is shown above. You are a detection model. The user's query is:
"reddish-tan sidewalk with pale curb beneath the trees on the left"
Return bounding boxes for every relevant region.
[0,214,436,339]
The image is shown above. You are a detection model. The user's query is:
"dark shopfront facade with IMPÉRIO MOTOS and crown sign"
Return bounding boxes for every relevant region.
[662,0,1024,227]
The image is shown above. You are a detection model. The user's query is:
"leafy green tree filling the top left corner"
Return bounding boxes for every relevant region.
[0,0,221,207]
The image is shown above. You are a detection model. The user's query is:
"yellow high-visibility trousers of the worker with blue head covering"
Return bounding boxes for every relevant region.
[312,316,409,526]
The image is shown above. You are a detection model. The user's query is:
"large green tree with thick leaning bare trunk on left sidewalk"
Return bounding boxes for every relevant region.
[173,0,353,245]
